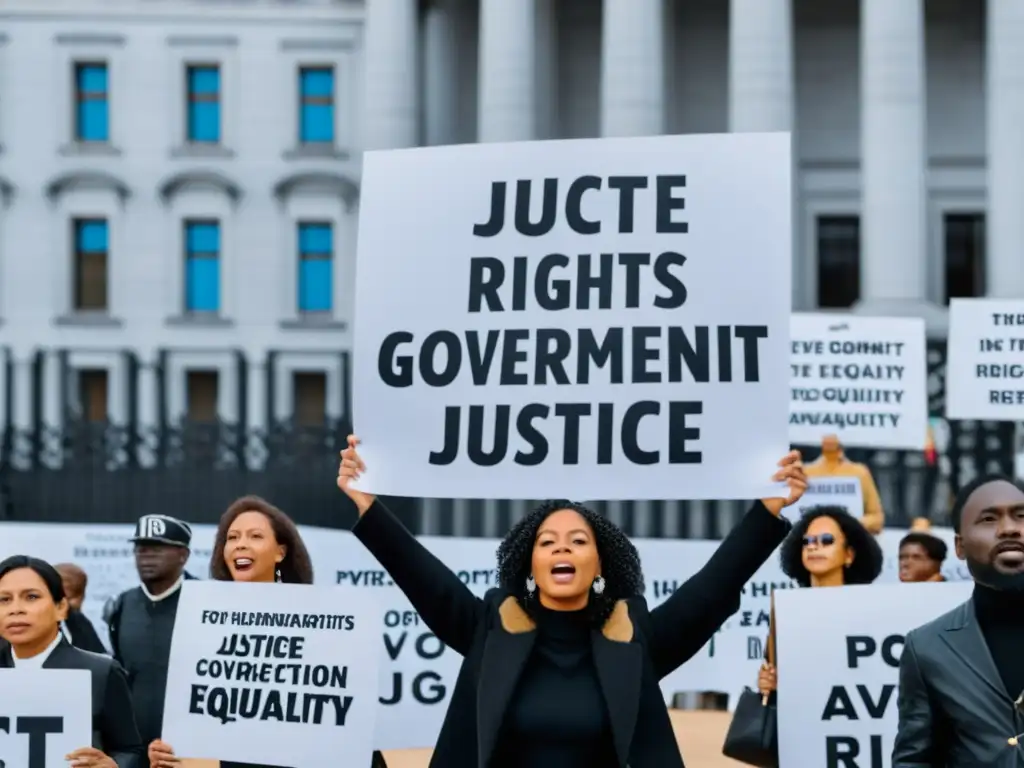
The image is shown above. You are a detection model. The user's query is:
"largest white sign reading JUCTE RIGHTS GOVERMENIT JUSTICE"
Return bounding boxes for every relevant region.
[353,134,792,499]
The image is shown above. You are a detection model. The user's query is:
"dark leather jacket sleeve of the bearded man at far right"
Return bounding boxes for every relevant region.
[892,632,946,768]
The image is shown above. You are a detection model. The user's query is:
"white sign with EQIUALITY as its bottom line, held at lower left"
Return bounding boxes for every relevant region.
[163,582,380,768]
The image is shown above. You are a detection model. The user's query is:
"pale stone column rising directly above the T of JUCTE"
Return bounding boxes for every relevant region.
[601,0,665,136]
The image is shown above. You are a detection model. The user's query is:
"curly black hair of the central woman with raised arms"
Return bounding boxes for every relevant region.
[498,499,644,626]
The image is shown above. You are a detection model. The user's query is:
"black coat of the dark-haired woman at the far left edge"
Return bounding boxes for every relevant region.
[0,638,148,768]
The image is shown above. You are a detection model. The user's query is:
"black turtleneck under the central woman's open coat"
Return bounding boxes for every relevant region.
[492,606,617,768]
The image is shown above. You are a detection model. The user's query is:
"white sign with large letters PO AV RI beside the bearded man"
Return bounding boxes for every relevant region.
[775,583,973,768]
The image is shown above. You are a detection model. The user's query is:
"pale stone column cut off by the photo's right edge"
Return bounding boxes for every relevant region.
[985,0,1024,299]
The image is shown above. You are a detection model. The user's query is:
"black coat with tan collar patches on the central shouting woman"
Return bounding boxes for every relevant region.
[352,501,790,768]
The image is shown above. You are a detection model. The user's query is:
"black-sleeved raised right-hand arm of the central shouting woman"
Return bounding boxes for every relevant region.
[649,500,790,678]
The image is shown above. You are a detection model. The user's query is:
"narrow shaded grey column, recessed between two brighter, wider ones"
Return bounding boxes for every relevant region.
[423,0,459,146]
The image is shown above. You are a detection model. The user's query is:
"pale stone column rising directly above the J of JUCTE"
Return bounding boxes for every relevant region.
[476,0,537,141]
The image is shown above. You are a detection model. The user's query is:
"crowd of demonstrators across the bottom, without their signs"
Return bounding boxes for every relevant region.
[0,437,1024,768]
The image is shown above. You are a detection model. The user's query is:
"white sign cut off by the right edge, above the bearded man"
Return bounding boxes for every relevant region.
[946,299,1024,421]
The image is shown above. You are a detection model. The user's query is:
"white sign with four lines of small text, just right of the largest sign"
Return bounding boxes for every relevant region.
[790,313,928,451]
